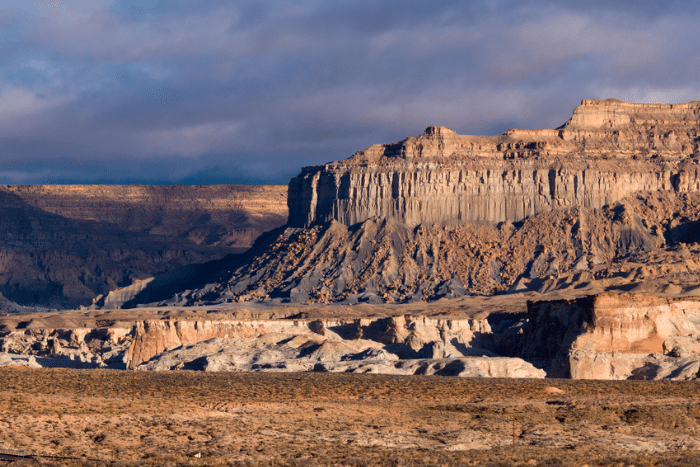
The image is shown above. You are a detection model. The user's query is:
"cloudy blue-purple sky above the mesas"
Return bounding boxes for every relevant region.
[0,0,700,184]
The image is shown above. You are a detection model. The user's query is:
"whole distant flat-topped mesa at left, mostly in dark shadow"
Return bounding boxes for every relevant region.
[0,185,287,311]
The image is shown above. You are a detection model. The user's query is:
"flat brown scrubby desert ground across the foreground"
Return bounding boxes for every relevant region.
[0,368,700,466]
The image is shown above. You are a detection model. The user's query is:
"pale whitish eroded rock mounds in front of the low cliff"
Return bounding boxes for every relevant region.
[138,336,545,378]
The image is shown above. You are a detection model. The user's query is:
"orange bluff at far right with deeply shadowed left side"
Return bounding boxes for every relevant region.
[523,293,700,379]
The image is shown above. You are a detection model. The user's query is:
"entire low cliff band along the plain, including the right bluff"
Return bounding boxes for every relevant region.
[0,292,700,380]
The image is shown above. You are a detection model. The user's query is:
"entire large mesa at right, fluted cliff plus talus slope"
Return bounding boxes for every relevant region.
[98,100,700,307]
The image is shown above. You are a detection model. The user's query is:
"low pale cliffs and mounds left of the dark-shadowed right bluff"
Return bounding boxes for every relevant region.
[0,310,545,378]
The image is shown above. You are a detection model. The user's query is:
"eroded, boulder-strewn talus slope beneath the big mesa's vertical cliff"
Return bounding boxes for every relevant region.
[123,191,700,307]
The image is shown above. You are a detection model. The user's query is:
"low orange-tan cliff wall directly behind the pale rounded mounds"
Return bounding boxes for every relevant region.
[127,316,492,369]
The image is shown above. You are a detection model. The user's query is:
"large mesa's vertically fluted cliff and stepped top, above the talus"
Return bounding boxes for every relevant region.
[288,99,700,227]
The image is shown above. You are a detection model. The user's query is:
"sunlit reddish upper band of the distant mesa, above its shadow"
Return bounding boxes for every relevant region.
[0,185,287,251]
